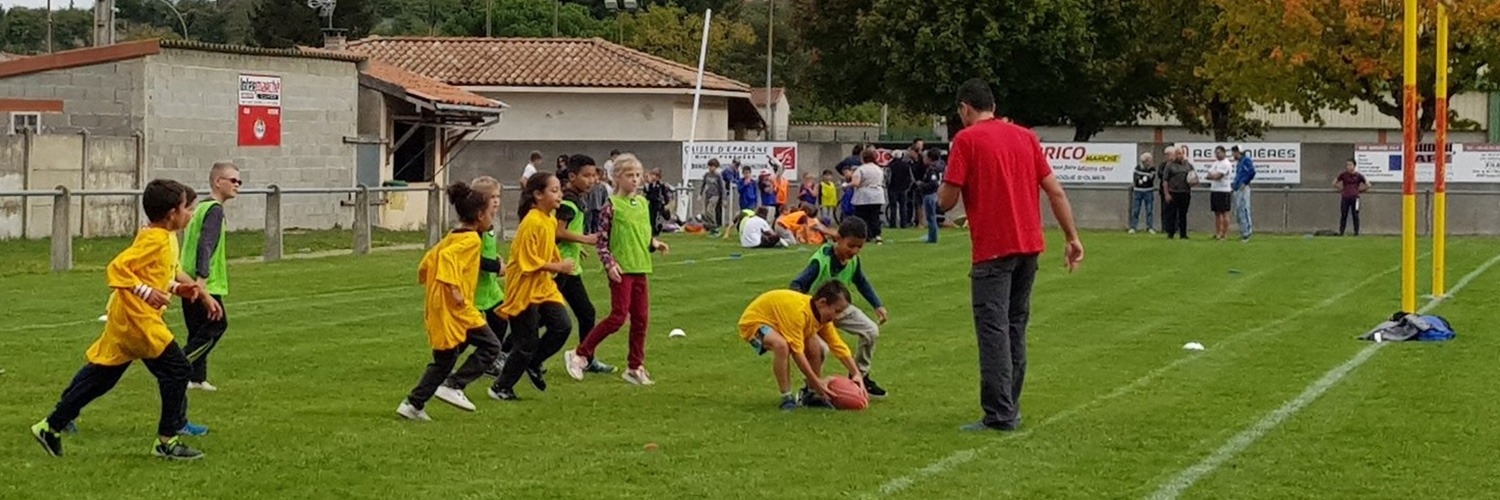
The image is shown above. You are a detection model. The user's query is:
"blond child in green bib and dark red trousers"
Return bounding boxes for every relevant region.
[564,155,668,386]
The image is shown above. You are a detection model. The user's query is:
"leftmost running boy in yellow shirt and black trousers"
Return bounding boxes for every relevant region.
[32,179,224,459]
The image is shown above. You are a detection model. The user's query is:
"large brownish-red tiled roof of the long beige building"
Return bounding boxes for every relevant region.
[350,36,750,92]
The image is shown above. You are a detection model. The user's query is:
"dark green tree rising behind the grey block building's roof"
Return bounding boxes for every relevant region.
[251,0,377,48]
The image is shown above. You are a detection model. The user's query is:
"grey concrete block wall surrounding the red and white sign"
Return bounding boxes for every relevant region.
[146,48,359,230]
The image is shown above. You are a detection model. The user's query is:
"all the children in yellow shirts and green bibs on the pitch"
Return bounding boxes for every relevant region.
[32,155,888,459]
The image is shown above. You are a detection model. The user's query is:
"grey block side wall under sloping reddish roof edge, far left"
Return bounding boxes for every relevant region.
[0,59,146,137]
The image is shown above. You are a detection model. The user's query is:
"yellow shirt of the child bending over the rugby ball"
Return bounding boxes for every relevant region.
[740,290,851,359]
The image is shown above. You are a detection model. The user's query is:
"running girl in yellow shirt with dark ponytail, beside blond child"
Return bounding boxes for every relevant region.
[489,173,578,401]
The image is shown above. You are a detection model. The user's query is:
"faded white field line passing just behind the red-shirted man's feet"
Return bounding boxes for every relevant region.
[864,258,1410,498]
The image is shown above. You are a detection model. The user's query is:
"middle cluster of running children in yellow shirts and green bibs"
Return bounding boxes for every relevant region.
[396,155,669,420]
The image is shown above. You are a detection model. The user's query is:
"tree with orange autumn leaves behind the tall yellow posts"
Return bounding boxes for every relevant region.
[1203,0,1500,131]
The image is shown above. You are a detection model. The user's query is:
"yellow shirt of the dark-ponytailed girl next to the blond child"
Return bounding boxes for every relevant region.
[497,209,563,320]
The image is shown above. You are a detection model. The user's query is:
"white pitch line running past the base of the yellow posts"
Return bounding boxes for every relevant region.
[1149,250,1500,500]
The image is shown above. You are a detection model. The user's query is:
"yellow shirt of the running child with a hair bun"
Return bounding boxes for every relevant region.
[417,231,485,351]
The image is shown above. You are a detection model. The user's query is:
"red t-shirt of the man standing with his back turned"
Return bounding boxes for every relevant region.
[944,120,1052,264]
